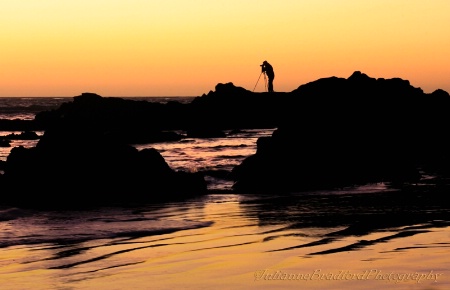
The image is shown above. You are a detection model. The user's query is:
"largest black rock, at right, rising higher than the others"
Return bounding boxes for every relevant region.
[232,72,450,192]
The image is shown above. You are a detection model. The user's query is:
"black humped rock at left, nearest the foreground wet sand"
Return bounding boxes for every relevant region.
[0,107,206,208]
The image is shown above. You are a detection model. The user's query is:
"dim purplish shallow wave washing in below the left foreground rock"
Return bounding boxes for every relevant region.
[0,208,212,248]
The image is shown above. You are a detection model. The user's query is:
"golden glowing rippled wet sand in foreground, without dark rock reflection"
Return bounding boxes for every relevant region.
[0,191,450,289]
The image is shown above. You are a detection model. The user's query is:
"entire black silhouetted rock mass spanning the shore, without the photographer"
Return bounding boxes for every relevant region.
[0,71,450,204]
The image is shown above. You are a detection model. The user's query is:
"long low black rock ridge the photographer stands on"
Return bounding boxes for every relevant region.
[34,88,289,134]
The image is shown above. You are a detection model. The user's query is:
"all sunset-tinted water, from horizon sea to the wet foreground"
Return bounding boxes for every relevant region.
[0,97,450,290]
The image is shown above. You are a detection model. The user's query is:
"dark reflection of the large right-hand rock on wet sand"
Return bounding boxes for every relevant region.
[237,185,450,255]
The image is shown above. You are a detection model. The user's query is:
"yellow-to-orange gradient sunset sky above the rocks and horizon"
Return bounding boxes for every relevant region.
[0,0,450,97]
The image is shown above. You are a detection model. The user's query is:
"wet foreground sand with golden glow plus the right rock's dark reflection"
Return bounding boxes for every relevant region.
[0,191,450,289]
